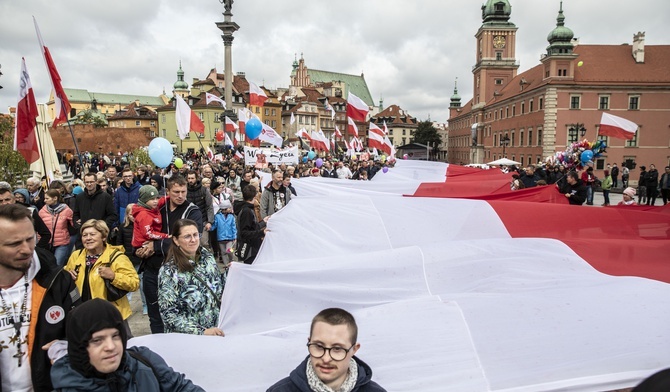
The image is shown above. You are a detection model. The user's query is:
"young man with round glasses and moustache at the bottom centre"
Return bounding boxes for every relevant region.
[268,308,385,392]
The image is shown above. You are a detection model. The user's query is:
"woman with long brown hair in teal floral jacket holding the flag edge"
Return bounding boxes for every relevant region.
[158,219,223,336]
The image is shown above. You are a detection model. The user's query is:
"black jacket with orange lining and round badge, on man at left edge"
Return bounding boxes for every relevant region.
[24,248,81,392]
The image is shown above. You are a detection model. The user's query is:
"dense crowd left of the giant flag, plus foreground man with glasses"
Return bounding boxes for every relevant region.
[0,149,396,391]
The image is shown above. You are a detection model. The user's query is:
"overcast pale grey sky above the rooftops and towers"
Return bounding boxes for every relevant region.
[0,0,670,122]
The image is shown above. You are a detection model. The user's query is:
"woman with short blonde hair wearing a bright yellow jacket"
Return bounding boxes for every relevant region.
[64,219,140,332]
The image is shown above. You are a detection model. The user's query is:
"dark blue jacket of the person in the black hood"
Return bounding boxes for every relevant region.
[51,347,204,392]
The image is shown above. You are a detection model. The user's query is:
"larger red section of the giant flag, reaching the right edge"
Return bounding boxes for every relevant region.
[489,201,670,283]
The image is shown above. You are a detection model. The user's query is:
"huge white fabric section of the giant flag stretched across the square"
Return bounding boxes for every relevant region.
[131,162,670,392]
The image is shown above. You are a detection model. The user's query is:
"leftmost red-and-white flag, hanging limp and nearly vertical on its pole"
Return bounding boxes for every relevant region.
[14,58,40,163]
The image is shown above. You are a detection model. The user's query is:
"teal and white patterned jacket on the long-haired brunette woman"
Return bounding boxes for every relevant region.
[158,247,224,335]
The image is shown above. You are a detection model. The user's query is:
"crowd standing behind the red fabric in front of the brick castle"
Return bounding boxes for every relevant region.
[501,163,670,206]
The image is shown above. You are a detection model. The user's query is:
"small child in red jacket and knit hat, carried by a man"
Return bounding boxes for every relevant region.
[132,185,169,248]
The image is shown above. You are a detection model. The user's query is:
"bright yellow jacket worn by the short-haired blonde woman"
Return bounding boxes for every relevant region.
[64,244,140,320]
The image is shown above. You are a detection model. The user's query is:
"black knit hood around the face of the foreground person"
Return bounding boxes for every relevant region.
[66,298,128,378]
